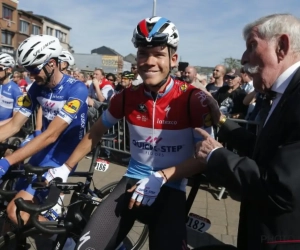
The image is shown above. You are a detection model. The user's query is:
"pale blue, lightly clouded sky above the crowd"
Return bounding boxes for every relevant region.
[19,0,300,67]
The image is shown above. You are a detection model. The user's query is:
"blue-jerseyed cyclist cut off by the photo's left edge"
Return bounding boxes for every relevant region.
[0,53,23,125]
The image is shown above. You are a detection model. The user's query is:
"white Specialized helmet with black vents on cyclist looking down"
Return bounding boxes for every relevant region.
[17,35,62,67]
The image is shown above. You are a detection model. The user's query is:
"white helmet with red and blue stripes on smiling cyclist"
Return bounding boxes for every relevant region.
[131,17,179,48]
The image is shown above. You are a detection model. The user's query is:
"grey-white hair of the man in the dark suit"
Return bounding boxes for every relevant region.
[243,14,300,52]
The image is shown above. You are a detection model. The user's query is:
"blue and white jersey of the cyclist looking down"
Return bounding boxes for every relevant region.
[19,75,88,167]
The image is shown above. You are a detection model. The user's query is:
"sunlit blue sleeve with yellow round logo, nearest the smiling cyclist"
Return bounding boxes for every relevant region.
[57,81,88,124]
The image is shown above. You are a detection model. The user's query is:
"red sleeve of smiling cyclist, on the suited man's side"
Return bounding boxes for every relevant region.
[189,90,214,143]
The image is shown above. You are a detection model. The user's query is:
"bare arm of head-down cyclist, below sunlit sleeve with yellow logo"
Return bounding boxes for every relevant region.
[6,116,69,165]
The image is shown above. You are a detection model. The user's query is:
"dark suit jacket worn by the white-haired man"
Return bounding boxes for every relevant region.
[208,65,300,250]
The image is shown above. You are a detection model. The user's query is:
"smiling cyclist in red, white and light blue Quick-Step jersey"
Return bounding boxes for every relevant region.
[54,17,212,250]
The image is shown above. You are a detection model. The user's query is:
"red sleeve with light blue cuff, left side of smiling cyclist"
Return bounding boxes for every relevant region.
[101,90,125,128]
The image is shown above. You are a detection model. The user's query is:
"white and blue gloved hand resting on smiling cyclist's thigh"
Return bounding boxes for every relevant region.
[128,172,166,208]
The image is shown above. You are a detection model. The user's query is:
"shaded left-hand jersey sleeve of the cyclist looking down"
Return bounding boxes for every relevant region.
[17,84,41,117]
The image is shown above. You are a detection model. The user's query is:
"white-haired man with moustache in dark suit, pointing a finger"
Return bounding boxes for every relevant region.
[129,14,300,250]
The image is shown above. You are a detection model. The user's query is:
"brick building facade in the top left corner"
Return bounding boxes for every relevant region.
[0,0,19,57]
